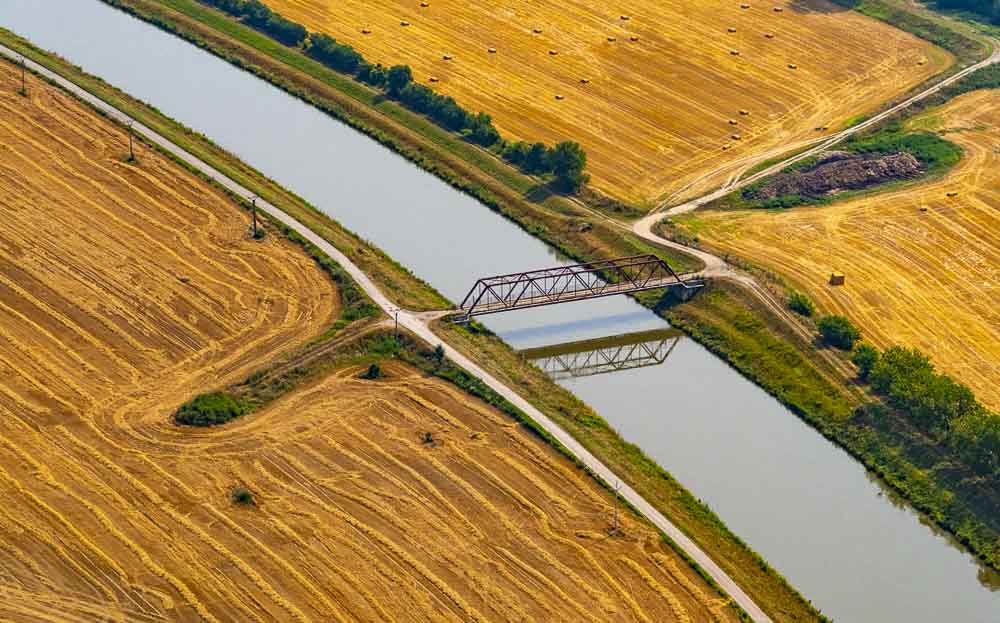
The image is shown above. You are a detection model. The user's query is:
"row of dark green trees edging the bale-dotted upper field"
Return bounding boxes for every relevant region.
[200,0,589,192]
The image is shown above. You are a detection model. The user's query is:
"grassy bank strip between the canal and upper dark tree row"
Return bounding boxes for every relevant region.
[94,0,700,272]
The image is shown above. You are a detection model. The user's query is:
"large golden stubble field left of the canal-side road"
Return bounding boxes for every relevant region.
[0,59,734,622]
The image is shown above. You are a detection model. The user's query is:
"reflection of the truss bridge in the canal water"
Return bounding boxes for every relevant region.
[519,329,684,381]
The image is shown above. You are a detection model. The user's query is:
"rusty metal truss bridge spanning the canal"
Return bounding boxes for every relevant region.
[460,254,705,321]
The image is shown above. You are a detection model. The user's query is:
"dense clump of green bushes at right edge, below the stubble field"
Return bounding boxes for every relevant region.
[855,346,1000,479]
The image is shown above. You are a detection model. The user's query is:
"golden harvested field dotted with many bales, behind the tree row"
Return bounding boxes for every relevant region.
[267,0,952,202]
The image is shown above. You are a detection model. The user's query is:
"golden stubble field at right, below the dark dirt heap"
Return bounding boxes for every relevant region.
[676,91,1000,409]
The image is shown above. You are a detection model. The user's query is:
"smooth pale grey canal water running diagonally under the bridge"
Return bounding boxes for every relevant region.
[0,0,1000,623]
